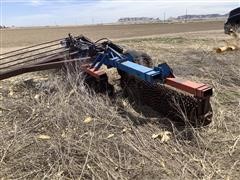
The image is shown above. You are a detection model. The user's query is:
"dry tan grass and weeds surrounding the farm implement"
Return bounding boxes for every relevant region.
[0,25,240,179]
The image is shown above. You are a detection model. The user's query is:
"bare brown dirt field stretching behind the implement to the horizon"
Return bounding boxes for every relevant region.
[0,21,223,48]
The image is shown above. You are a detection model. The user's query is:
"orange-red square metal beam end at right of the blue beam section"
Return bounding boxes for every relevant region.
[165,77,213,98]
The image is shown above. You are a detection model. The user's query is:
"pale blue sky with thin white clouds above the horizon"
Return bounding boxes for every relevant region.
[0,0,240,26]
